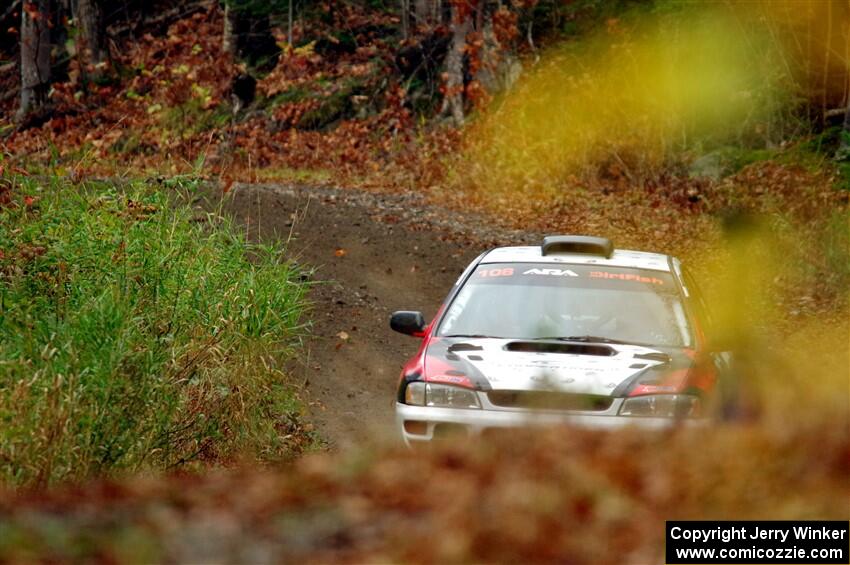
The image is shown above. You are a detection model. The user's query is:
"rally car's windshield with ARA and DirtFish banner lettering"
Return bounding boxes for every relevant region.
[437,263,691,347]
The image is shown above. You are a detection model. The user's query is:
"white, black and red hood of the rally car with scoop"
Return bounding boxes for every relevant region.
[424,338,692,396]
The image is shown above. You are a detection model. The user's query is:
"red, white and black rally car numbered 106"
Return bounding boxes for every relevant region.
[390,236,728,444]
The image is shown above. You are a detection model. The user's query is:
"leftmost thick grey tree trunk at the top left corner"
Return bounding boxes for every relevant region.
[17,0,51,120]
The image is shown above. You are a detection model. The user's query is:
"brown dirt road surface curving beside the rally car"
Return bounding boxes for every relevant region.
[212,184,539,449]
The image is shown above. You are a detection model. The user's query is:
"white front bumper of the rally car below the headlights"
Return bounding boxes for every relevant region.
[396,402,705,445]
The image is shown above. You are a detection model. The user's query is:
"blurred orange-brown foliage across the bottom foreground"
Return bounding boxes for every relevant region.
[0,424,850,564]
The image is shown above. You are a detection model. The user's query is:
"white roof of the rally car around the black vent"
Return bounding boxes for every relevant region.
[480,245,671,272]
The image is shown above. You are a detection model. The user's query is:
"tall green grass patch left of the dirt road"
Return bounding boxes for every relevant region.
[0,177,312,485]
